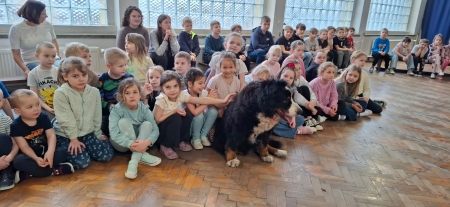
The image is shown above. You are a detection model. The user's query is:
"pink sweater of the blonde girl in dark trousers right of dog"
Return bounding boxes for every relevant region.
[309,77,338,114]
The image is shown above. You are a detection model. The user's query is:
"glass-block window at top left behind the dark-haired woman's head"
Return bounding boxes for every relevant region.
[0,0,108,26]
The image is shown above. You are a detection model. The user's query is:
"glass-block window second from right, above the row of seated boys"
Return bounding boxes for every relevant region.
[284,0,354,30]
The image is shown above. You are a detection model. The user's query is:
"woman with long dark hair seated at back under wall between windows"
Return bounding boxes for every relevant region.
[116,6,150,54]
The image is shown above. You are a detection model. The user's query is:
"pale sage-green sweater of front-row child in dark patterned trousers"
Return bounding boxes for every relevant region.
[53,83,102,139]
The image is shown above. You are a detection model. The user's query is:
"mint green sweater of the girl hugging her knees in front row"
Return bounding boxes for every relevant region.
[109,102,159,148]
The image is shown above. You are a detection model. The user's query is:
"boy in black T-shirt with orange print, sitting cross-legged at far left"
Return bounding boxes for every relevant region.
[10,89,73,183]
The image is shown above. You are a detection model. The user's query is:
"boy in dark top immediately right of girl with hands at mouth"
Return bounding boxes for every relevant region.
[178,17,200,66]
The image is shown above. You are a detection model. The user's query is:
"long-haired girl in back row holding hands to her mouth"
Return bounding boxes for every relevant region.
[149,14,180,70]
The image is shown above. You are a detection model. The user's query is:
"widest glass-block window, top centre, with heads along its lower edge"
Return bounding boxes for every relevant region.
[139,0,264,30]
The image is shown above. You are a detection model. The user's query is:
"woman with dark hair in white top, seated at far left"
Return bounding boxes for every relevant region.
[9,0,59,77]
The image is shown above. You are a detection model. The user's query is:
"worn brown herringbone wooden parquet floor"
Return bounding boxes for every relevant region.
[0,63,450,207]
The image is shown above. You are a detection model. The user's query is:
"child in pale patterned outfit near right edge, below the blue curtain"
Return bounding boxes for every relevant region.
[428,34,445,79]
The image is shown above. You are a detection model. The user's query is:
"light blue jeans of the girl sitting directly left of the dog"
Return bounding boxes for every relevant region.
[191,107,217,139]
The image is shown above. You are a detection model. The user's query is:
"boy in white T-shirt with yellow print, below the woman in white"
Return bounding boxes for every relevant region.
[27,42,59,120]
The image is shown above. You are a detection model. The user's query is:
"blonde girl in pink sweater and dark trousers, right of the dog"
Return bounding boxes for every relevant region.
[309,62,346,121]
